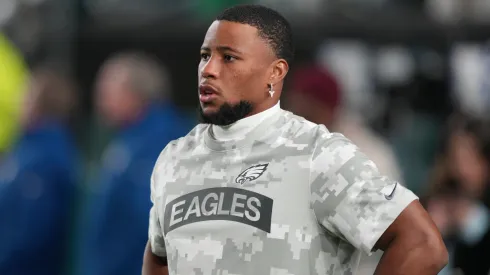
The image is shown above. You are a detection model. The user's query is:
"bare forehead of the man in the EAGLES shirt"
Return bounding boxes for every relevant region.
[203,20,265,52]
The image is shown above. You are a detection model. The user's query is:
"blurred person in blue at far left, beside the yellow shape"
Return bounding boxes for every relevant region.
[0,67,78,275]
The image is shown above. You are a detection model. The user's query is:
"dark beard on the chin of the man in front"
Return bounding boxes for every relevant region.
[198,100,253,126]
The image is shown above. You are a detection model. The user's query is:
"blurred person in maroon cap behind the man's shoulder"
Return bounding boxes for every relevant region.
[284,65,401,275]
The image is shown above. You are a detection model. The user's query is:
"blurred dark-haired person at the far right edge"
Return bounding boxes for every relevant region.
[427,116,490,275]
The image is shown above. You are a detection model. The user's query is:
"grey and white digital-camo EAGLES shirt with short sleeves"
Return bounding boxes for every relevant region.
[149,110,416,275]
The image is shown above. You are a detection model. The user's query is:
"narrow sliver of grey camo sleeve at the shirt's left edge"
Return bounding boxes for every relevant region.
[148,175,167,257]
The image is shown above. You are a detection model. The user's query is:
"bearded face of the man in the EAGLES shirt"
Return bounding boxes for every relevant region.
[198,21,276,125]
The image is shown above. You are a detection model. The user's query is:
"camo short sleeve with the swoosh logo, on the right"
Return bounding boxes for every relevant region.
[310,131,418,255]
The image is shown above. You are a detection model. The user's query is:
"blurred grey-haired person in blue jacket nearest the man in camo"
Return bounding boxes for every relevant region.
[78,52,193,275]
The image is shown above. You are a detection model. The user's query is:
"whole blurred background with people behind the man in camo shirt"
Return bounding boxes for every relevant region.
[0,0,490,275]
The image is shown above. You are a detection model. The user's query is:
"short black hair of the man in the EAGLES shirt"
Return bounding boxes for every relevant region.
[216,5,294,63]
